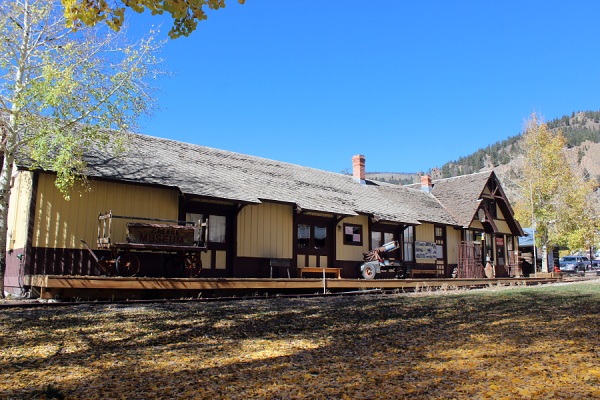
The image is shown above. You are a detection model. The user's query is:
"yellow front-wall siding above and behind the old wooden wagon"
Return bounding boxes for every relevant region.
[33,173,179,248]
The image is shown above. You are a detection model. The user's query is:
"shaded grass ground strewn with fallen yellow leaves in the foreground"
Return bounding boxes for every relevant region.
[0,280,600,399]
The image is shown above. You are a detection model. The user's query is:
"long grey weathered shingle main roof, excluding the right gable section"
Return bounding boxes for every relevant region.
[77,134,460,226]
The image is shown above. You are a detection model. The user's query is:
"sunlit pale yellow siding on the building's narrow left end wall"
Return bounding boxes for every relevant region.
[6,171,33,250]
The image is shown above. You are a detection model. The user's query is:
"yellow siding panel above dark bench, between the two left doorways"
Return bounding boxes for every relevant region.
[237,203,294,258]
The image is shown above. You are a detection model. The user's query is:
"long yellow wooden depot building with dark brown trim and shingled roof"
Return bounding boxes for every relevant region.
[5,134,523,292]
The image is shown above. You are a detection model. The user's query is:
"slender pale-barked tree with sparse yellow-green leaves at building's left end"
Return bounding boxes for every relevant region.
[0,0,162,297]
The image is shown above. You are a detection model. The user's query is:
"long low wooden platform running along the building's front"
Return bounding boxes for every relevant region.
[24,275,559,300]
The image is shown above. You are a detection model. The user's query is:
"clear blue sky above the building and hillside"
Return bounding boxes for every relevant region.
[128,0,600,172]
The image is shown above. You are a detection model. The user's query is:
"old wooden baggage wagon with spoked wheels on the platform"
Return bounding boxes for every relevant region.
[81,211,208,278]
